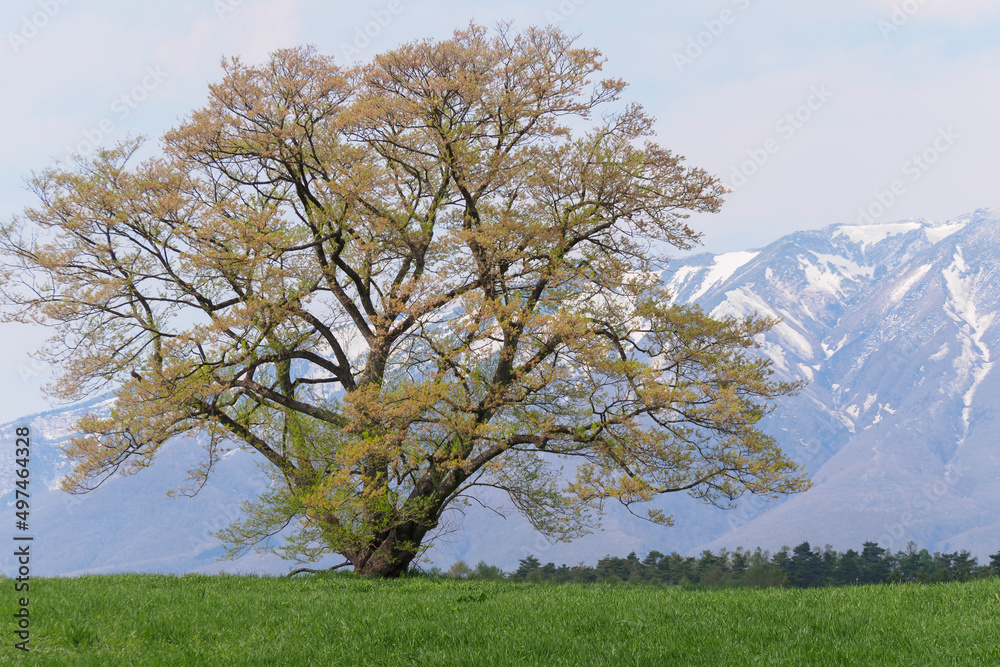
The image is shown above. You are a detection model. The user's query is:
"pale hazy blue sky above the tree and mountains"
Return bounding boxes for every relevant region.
[0,0,1000,423]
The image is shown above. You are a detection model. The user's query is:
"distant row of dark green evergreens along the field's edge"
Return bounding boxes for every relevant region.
[429,542,1000,588]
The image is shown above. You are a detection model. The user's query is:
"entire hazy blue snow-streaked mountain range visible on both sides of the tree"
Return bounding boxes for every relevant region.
[0,210,1000,575]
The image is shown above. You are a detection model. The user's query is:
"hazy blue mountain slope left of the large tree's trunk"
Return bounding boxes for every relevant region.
[0,399,348,576]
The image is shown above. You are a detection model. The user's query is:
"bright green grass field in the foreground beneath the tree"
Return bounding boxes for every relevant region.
[0,575,1000,667]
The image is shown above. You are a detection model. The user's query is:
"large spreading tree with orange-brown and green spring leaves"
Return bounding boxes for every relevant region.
[0,25,807,576]
